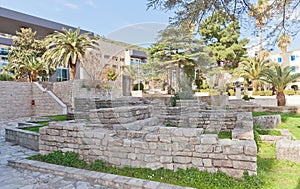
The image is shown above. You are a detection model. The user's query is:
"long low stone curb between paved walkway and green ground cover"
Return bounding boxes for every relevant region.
[8,159,193,189]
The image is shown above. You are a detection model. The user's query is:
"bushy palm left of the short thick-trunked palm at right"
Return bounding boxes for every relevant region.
[239,57,270,91]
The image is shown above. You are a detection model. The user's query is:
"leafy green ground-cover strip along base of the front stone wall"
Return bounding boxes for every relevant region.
[29,151,262,189]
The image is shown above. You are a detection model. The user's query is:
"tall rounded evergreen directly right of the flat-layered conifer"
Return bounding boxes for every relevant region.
[199,10,249,68]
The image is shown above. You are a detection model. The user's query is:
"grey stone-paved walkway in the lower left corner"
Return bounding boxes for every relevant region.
[0,119,110,189]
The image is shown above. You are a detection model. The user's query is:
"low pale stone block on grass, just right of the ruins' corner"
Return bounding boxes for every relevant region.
[253,115,281,129]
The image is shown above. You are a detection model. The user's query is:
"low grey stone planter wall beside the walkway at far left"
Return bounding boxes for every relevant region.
[5,128,40,151]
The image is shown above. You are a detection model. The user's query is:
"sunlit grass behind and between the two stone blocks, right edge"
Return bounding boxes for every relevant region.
[252,112,300,140]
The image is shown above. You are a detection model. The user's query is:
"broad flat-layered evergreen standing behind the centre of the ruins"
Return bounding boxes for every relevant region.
[148,27,211,91]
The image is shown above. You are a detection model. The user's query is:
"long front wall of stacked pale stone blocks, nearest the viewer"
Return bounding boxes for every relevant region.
[40,122,257,178]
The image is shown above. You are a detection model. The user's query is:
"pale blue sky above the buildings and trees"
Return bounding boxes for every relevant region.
[0,0,300,51]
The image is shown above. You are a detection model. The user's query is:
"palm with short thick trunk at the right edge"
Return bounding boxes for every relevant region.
[263,65,300,106]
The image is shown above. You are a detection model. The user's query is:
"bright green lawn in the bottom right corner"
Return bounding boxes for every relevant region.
[257,143,300,189]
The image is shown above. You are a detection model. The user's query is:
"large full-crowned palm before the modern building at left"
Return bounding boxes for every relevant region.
[43,27,96,80]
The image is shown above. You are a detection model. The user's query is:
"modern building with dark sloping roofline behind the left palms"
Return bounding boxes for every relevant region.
[0,7,147,81]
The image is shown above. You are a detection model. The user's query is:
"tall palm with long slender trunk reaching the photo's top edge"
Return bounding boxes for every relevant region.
[249,0,270,57]
